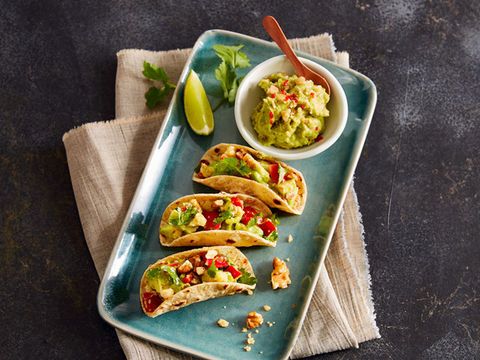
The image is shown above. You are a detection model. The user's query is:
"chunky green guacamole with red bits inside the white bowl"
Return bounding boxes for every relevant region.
[251,73,330,149]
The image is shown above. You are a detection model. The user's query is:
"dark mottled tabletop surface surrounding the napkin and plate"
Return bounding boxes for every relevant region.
[0,0,480,359]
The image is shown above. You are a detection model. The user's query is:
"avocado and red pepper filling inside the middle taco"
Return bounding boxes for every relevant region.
[160,196,279,241]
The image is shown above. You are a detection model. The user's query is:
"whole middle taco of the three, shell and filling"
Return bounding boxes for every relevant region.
[160,193,278,247]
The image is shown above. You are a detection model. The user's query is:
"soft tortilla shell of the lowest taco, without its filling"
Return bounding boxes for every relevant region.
[140,246,256,317]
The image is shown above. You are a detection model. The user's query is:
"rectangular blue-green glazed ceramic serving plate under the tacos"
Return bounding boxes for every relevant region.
[98,30,376,359]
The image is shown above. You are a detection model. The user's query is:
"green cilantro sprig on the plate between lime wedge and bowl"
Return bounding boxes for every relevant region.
[213,44,250,111]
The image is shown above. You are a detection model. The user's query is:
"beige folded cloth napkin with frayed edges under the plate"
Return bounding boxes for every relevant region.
[63,34,380,359]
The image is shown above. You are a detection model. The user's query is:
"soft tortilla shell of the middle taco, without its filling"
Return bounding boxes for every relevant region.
[160,193,277,247]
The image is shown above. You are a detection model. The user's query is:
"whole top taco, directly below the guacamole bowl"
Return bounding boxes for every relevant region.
[193,144,307,214]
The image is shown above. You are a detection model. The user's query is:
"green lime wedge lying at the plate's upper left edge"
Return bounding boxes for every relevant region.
[183,70,214,135]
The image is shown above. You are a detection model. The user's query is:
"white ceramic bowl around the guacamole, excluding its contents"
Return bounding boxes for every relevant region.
[235,55,348,160]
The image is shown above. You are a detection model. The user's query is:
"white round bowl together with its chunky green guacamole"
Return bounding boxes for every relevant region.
[234,55,348,160]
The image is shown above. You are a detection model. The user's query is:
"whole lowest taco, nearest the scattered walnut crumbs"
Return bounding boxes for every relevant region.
[140,246,257,317]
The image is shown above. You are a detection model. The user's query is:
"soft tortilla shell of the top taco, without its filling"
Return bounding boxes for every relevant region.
[193,144,307,215]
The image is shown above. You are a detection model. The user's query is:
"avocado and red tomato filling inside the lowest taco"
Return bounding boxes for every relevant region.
[142,249,257,312]
